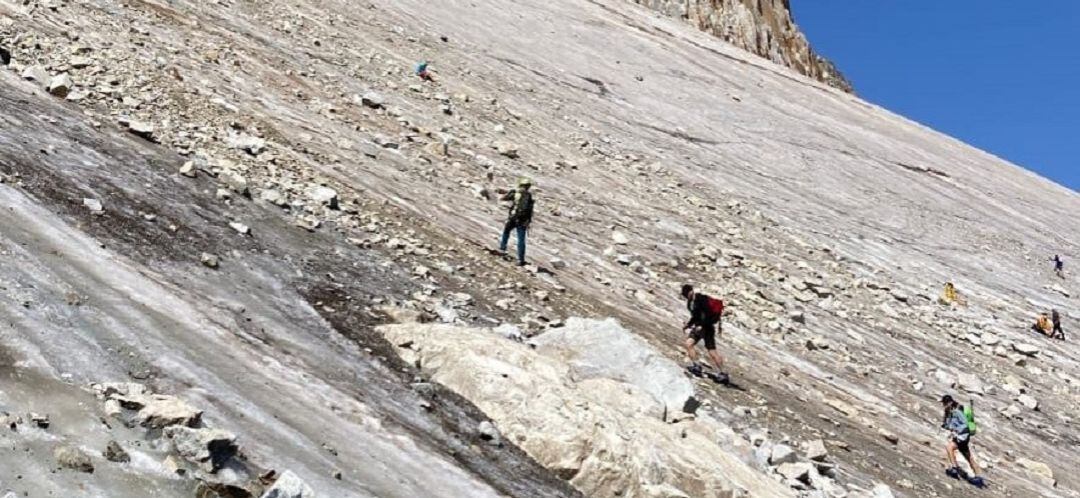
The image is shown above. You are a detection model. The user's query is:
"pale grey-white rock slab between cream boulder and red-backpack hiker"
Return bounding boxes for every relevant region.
[532,318,693,414]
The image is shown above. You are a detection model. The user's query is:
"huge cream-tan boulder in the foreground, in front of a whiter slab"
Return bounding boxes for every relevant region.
[379,324,792,498]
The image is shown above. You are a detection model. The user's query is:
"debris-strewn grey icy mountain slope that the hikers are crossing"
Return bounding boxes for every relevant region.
[0,0,1080,496]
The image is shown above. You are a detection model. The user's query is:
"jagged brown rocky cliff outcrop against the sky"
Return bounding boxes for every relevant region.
[633,0,854,92]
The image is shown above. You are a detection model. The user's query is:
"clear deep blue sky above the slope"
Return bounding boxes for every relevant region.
[792,0,1080,190]
